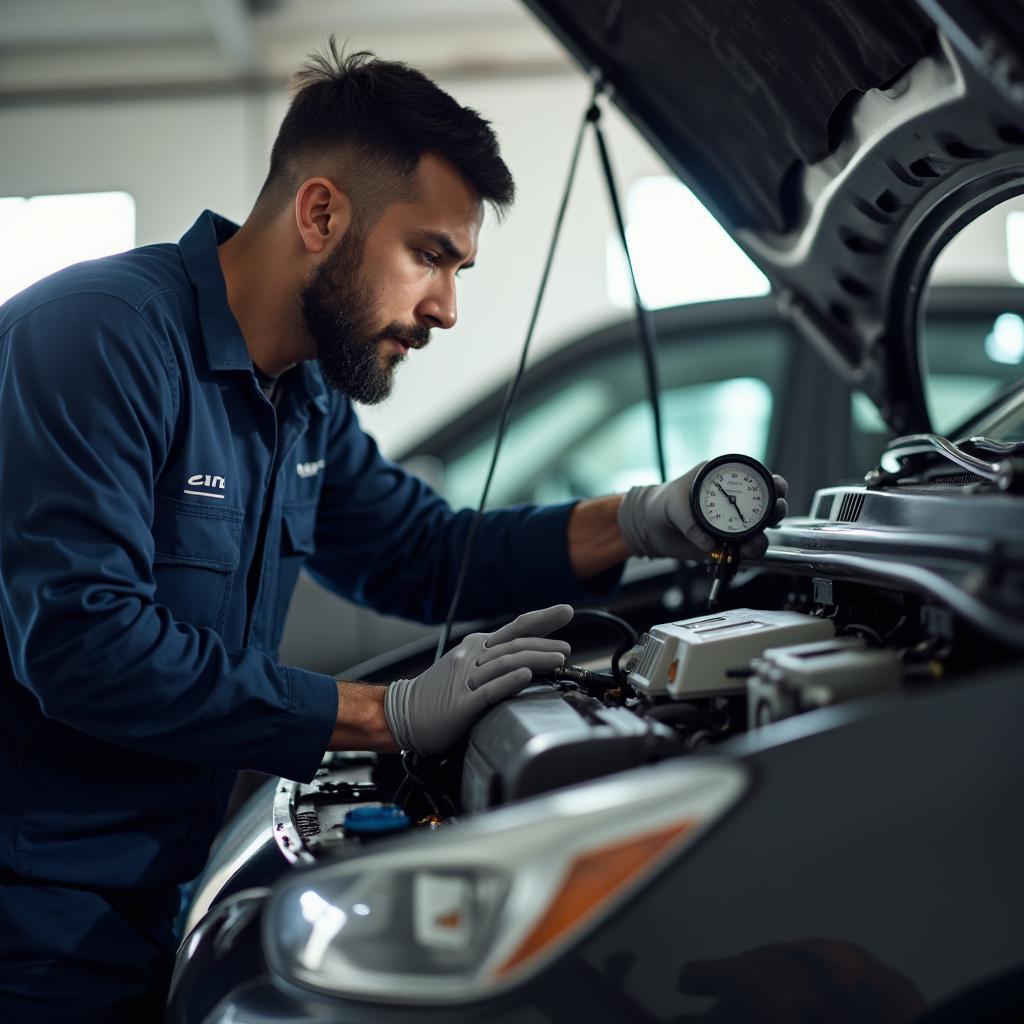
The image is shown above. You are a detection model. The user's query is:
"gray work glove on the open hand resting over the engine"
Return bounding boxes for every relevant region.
[384,604,572,754]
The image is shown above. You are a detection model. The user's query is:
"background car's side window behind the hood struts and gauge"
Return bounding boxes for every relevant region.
[433,325,794,507]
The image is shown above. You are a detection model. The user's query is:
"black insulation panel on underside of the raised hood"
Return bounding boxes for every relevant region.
[535,0,934,232]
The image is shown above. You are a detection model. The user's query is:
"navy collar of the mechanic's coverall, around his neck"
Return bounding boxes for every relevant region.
[178,210,329,412]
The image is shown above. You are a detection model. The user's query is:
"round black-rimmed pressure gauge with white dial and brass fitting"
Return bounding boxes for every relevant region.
[690,455,777,609]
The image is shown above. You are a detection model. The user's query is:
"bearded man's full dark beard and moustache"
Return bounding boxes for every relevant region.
[299,229,430,406]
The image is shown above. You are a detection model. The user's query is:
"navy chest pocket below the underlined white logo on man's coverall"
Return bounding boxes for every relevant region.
[153,498,245,633]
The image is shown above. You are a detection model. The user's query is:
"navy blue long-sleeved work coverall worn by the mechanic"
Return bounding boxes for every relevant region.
[0,212,614,1021]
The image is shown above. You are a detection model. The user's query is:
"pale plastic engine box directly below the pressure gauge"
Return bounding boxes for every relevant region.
[629,608,836,700]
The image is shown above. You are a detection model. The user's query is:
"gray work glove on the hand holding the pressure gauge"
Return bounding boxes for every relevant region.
[618,462,788,562]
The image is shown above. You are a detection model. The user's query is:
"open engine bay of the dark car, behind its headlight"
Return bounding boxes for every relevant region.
[274,481,1024,862]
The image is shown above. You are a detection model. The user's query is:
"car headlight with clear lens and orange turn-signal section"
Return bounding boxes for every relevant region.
[263,759,746,1002]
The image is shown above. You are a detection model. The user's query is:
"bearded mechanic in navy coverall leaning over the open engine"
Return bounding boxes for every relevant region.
[0,41,784,1024]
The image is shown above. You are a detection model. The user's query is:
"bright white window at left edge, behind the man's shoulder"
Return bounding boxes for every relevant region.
[0,191,135,302]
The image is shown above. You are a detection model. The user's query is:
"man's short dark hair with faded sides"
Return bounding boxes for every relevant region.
[255,36,515,225]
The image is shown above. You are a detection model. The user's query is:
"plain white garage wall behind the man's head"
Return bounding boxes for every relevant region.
[0,73,663,455]
